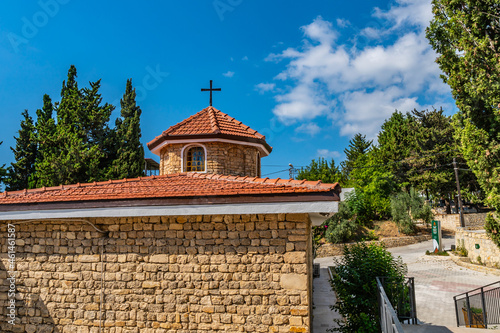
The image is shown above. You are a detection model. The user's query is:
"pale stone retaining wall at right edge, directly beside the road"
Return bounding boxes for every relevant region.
[455,228,500,268]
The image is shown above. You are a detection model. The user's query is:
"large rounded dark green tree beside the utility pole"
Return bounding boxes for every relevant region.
[378,109,479,213]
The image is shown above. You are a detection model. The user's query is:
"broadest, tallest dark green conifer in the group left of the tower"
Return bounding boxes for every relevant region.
[37,66,114,186]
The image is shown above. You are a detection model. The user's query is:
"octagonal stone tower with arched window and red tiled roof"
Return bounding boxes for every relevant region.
[148,106,272,177]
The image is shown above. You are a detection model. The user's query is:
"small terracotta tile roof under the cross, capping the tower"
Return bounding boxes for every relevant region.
[148,106,270,149]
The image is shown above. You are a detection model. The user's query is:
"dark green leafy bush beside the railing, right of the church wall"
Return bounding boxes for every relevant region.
[332,243,407,333]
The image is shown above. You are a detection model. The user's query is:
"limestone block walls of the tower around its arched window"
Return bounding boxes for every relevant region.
[160,142,260,177]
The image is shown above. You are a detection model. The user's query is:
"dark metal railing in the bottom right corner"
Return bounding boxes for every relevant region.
[453,281,500,328]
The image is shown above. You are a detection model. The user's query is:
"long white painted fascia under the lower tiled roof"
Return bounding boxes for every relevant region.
[0,201,339,225]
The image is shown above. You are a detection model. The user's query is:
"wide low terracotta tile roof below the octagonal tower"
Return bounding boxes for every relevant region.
[0,173,340,206]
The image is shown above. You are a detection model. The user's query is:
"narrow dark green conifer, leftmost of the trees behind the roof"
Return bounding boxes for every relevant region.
[4,110,37,191]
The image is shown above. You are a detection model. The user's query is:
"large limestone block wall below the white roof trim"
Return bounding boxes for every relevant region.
[0,214,312,333]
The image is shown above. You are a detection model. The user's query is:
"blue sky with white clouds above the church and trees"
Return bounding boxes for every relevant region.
[0,0,456,178]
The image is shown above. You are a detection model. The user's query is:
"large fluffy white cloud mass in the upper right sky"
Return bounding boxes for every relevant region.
[265,0,451,138]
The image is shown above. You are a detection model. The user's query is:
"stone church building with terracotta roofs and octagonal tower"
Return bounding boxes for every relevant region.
[0,106,340,333]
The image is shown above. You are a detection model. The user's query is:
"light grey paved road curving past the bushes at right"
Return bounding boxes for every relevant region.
[314,238,500,333]
